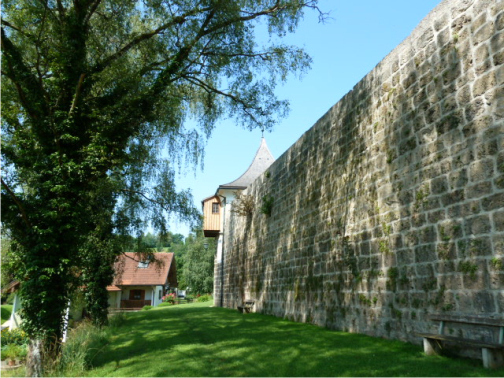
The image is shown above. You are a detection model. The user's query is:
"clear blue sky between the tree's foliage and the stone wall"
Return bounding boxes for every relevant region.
[170,0,441,235]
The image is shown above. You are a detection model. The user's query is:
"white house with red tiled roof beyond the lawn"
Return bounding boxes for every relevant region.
[107,252,178,310]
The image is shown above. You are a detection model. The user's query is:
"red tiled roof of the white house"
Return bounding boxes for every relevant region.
[111,252,174,284]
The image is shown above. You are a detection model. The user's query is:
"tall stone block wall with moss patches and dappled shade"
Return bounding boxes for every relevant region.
[215,0,504,343]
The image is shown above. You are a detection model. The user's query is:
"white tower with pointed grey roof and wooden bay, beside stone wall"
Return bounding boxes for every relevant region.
[201,136,275,306]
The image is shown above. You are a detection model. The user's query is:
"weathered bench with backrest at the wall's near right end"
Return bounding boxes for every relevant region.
[416,315,504,368]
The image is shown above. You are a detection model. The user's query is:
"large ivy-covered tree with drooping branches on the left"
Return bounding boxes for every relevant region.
[1,0,318,375]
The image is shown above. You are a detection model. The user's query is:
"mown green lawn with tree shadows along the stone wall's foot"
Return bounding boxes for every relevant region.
[81,302,504,377]
